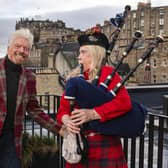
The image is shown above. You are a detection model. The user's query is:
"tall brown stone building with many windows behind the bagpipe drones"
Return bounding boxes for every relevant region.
[101,1,168,84]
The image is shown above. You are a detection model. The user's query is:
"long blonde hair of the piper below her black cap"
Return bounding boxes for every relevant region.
[67,45,106,81]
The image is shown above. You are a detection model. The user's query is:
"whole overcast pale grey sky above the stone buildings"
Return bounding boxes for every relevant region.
[0,0,168,56]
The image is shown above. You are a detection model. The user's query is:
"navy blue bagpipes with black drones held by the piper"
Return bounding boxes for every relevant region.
[60,6,163,163]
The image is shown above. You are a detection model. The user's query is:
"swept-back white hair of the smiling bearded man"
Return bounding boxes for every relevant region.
[8,28,33,48]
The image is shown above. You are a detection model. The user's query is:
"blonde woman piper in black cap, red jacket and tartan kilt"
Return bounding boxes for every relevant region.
[57,29,131,168]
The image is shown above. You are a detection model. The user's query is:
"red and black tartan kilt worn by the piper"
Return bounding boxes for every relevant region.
[66,133,127,168]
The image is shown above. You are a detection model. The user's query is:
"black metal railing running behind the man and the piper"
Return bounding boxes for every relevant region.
[24,95,168,168]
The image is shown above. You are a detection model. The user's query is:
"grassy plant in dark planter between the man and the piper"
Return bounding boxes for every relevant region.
[22,133,59,168]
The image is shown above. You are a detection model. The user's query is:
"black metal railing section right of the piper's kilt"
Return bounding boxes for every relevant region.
[123,112,168,168]
